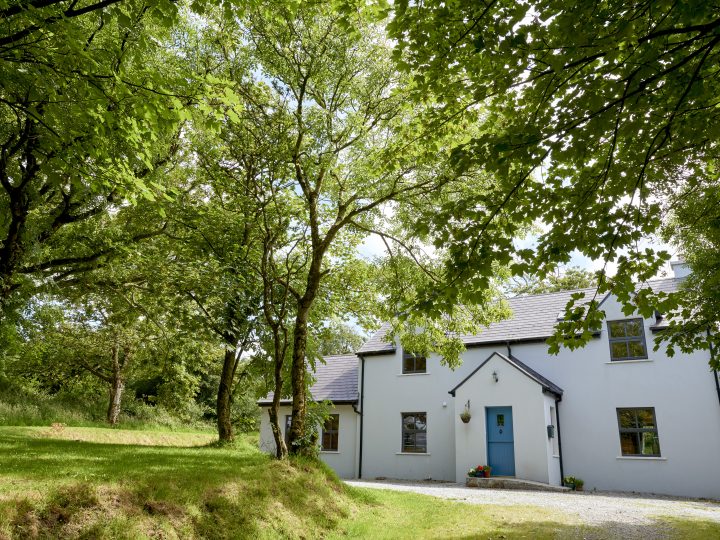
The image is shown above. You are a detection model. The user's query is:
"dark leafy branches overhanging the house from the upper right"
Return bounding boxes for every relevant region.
[388,0,720,358]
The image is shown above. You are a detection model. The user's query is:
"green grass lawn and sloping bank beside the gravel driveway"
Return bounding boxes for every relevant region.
[0,427,720,540]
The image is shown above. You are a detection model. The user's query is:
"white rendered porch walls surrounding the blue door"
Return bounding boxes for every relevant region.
[454,353,559,483]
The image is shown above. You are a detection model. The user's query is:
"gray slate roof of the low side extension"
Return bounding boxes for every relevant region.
[258,354,358,405]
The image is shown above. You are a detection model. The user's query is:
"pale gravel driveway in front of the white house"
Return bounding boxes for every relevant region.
[347,480,720,538]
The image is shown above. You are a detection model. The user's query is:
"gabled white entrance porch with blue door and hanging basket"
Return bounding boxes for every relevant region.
[450,352,562,489]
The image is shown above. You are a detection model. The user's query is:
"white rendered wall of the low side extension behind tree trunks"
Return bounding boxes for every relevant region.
[260,405,359,478]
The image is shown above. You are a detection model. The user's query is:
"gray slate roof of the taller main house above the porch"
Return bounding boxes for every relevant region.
[358,278,681,356]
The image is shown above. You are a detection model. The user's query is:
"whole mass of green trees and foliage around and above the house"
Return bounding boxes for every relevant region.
[0,0,720,448]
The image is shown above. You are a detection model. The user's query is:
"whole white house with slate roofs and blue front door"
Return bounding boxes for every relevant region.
[260,270,720,498]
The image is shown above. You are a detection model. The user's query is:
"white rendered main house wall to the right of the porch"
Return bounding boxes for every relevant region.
[496,298,720,498]
